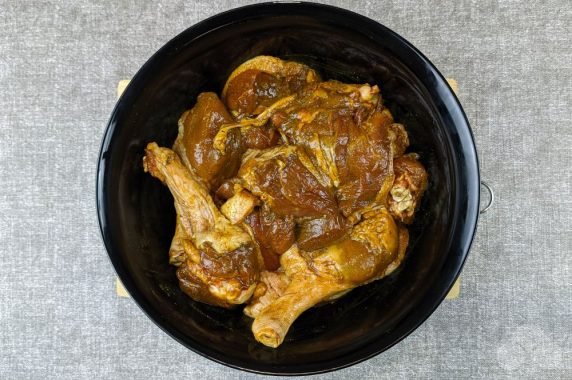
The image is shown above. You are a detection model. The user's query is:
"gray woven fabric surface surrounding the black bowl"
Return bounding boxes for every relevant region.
[0,0,572,379]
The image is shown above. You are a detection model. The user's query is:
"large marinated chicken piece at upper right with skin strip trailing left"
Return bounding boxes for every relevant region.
[214,81,409,217]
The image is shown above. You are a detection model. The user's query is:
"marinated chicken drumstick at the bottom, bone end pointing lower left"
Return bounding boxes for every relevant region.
[245,208,407,347]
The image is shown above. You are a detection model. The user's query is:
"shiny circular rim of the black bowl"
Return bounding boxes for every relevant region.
[95,1,480,376]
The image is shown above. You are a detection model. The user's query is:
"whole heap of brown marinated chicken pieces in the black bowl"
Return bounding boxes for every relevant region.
[144,56,428,347]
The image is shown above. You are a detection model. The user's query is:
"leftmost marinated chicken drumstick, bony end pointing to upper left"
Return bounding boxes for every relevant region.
[143,143,260,307]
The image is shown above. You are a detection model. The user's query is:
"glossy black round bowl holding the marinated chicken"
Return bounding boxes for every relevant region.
[97,3,480,374]
